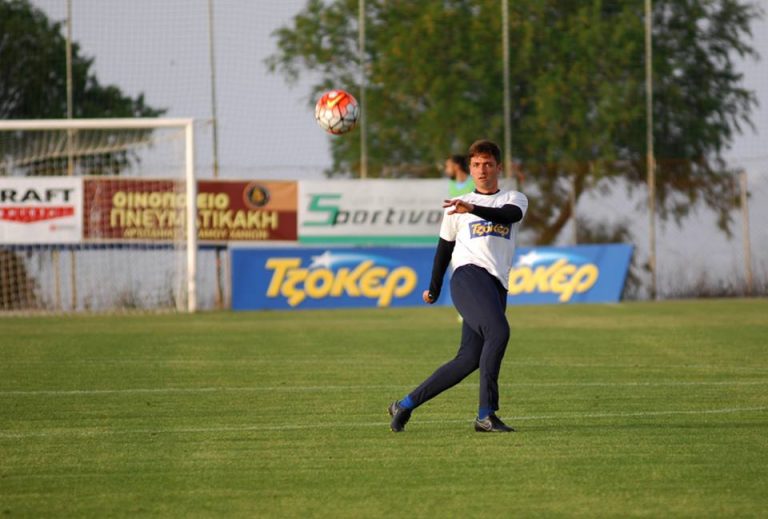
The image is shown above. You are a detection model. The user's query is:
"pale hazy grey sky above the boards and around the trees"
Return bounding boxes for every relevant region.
[33,0,768,177]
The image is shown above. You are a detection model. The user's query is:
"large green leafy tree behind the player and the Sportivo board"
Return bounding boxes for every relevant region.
[267,0,762,244]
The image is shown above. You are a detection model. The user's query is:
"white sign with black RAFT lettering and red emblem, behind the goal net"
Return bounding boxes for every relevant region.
[0,177,83,244]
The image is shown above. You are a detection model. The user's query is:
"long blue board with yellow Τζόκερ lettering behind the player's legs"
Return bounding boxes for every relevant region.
[231,244,632,310]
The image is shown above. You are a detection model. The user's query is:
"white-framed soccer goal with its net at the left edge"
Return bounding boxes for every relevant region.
[0,118,197,312]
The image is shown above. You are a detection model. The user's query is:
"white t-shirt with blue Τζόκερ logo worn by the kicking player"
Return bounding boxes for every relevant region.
[440,191,528,289]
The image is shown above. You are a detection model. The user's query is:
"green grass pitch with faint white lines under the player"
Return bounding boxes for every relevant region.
[0,300,768,518]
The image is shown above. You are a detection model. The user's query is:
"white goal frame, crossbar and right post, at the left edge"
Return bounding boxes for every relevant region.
[0,117,197,313]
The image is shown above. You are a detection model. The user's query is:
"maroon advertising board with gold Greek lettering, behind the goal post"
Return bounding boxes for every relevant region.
[84,178,297,242]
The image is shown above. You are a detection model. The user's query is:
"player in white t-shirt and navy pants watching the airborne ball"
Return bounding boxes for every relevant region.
[388,140,528,432]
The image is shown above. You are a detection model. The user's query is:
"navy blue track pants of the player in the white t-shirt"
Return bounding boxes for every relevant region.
[410,265,509,410]
